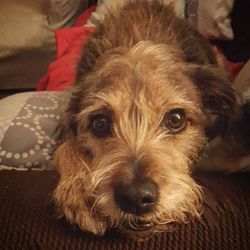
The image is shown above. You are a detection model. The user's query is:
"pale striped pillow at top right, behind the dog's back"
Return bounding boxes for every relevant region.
[197,0,234,40]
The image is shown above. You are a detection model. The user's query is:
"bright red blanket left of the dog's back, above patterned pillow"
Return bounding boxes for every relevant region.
[36,6,95,91]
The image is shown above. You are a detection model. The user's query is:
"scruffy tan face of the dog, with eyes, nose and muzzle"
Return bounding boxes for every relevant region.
[54,42,238,238]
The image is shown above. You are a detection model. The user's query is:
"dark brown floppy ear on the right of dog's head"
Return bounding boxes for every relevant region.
[188,65,239,139]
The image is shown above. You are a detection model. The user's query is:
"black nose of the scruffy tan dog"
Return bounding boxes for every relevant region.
[114,180,159,215]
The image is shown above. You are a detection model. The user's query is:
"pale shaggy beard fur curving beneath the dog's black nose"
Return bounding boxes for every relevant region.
[92,176,202,236]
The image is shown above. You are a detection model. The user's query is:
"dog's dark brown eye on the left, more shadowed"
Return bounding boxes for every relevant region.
[90,115,111,138]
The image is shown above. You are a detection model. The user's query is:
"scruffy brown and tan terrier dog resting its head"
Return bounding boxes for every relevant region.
[54,0,237,239]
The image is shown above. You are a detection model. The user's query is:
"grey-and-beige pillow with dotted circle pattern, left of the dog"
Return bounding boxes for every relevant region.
[0,92,67,170]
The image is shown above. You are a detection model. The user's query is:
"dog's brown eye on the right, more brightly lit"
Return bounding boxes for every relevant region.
[164,109,187,133]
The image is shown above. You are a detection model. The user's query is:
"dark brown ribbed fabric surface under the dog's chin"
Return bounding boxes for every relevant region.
[0,171,250,250]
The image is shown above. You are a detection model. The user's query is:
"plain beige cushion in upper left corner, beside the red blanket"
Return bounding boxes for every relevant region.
[0,0,88,89]
